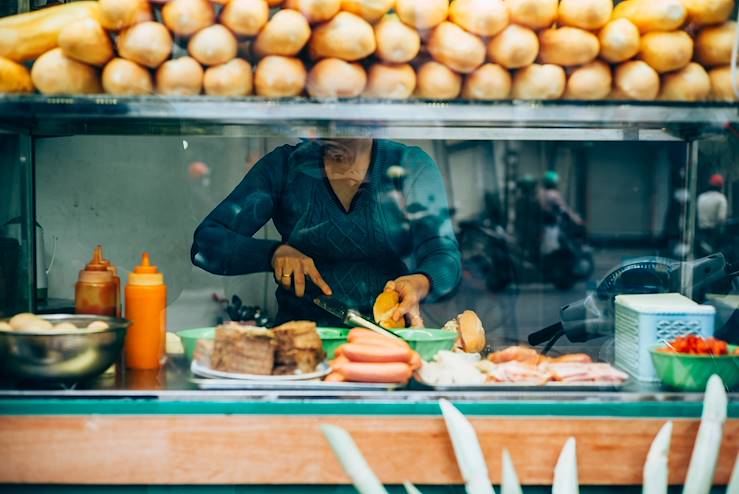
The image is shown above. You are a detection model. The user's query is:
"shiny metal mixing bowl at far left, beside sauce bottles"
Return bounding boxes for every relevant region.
[0,314,131,382]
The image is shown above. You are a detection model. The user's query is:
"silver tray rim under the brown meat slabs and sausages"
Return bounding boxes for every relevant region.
[190,378,403,391]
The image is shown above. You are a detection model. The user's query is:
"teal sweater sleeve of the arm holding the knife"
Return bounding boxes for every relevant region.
[190,146,292,275]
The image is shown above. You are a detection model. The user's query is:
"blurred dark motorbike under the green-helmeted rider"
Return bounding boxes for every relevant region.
[458,210,594,291]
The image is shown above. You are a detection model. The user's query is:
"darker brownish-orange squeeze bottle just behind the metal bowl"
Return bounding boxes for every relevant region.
[74,245,116,317]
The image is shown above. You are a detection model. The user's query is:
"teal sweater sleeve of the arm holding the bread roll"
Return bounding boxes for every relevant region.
[403,147,462,302]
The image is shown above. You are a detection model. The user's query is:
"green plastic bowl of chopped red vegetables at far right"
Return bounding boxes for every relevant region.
[650,345,739,391]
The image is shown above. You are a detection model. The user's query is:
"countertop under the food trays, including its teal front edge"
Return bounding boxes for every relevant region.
[0,356,739,418]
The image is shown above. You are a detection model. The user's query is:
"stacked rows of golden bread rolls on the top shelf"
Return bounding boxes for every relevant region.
[0,0,739,101]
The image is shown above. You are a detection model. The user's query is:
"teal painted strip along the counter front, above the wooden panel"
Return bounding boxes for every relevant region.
[0,398,739,418]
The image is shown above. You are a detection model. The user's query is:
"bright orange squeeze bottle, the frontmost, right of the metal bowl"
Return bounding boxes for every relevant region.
[125,252,167,369]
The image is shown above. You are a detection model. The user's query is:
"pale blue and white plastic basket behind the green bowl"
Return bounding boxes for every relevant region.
[616,293,716,382]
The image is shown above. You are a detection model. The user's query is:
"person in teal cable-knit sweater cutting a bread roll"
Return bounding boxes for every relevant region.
[191,139,461,326]
